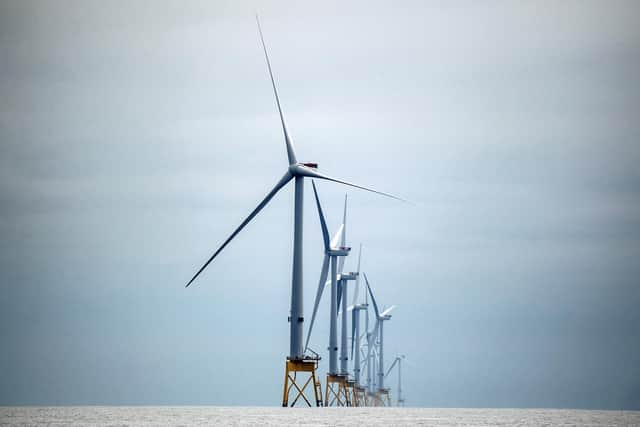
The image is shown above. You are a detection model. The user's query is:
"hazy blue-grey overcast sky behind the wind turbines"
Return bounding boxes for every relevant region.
[0,1,640,409]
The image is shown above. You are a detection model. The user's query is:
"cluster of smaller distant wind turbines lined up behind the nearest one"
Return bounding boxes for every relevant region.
[305,181,404,406]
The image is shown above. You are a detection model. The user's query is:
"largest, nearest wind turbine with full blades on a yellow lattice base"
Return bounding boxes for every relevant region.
[186,15,402,406]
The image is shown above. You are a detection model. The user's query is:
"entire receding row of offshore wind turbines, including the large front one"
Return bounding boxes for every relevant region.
[186,16,404,406]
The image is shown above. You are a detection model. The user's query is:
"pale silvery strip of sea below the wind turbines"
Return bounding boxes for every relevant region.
[0,406,640,426]
